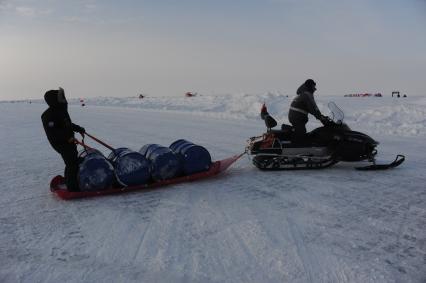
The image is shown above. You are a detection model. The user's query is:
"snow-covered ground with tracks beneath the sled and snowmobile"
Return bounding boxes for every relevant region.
[0,94,426,282]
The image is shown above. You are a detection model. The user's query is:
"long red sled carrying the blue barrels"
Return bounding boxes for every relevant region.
[50,153,244,200]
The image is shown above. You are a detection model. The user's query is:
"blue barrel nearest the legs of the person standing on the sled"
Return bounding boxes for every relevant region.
[78,149,114,191]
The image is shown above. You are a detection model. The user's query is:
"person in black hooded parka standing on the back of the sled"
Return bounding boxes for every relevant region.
[41,88,85,191]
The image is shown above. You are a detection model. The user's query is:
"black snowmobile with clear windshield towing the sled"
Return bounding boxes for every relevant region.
[247,102,405,170]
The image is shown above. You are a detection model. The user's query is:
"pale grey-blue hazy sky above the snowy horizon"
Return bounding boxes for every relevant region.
[0,0,426,100]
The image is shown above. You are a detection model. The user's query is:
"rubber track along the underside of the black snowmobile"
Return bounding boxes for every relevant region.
[253,155,339,171]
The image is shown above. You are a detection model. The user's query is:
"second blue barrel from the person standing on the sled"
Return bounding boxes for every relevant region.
[108,147,151,187]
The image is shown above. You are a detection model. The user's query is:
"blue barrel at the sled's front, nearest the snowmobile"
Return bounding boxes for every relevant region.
[170,140,212,175]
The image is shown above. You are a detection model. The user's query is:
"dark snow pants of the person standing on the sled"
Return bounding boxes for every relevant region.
[57,144,80,192]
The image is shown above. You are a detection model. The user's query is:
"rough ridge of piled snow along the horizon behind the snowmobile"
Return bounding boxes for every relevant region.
[10,93,426,136]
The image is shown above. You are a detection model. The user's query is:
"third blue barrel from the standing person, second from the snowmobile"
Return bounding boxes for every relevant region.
[139,144,182,181]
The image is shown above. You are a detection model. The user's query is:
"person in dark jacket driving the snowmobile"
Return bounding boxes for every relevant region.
[288,79,329,145]
